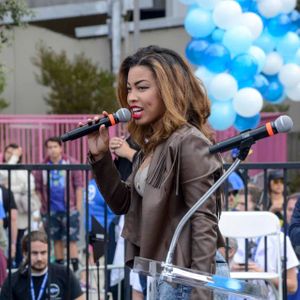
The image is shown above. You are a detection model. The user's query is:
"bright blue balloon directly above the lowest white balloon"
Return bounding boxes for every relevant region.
[229,53,258,82]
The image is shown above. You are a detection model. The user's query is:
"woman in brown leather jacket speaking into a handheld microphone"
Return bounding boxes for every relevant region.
[85,46,224,300]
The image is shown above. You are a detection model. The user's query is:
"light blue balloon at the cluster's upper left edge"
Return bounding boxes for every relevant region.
[184,8,215,38]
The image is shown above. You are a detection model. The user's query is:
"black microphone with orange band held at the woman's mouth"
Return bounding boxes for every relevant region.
[60,108,131,142]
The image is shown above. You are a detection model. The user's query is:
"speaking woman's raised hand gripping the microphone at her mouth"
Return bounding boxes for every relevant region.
[79,111,109,160]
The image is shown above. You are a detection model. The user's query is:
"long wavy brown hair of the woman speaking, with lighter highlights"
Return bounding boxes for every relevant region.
[117,46,212,153]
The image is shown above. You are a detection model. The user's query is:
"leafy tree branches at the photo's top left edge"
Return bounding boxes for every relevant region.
[0,0,31,110]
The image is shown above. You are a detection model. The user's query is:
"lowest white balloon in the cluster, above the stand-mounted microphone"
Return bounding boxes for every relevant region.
[233,88,263,117]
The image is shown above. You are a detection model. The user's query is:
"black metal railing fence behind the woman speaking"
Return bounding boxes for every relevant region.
[0,163,300,300]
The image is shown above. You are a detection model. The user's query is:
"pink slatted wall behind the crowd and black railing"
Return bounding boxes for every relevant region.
[0,114,287,163]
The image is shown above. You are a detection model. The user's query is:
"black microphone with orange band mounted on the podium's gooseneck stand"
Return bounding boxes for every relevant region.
[209,116,293,153]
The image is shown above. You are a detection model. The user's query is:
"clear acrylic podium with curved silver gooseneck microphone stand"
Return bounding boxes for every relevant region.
[133,144,268,300]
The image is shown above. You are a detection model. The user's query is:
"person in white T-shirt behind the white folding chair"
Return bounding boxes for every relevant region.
[231,185,299,299]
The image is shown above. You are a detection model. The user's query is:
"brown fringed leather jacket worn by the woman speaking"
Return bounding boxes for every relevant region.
[91,125,223,300]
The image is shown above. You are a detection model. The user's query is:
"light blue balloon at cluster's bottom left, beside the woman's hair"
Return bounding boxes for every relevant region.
[208,101,236,130]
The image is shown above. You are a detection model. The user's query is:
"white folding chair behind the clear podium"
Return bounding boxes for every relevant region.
[219,211,283,299]
